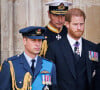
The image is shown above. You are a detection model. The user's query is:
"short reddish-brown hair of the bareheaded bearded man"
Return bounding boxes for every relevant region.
[65,8,86,22]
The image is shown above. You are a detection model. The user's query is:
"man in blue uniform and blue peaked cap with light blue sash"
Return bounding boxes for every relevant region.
[0,26,56,90]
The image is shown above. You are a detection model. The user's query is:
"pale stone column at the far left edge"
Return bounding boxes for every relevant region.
[1,0,13,62]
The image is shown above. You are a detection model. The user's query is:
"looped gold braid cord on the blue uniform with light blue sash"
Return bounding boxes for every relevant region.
[8,61,32,90]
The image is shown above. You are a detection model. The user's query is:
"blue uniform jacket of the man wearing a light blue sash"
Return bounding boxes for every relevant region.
[0,54,56,90]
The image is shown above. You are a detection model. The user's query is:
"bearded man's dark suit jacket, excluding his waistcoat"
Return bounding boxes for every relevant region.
[46,38,95,90]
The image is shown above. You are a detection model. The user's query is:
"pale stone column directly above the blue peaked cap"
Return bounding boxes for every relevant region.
[28,0,43,26]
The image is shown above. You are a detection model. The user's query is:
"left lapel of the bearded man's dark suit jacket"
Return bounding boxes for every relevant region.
[60,38,76,78]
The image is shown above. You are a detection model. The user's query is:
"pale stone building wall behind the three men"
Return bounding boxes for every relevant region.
[0,0,100,63]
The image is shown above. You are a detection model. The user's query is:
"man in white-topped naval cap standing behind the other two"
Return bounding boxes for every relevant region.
[45,0,72,44]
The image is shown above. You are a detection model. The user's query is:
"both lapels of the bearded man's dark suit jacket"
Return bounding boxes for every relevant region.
[60,38,91,82]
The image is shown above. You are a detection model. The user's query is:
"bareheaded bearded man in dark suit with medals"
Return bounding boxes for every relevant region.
[46,8,98,90]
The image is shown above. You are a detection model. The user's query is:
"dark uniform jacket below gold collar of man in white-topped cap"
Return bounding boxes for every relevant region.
[45,26,67,44]
